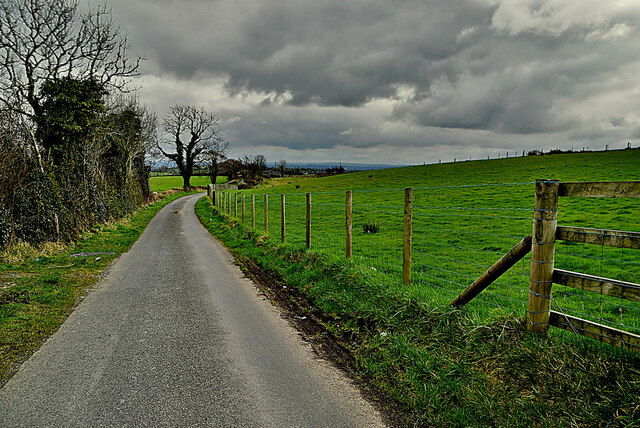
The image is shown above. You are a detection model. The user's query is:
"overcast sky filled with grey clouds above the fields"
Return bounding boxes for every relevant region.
[97,0,640,164]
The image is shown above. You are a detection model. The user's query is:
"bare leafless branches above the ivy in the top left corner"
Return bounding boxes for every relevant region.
[0,0,141,117]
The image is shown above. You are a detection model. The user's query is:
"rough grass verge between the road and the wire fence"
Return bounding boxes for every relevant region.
[196,198,640,427]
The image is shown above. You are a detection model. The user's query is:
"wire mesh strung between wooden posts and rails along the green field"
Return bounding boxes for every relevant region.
[214,183,640,346]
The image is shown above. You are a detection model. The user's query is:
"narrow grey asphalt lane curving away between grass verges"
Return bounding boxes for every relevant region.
[0,195,383,427]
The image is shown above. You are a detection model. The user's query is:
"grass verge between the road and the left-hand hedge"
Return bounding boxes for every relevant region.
[0,193,195,387]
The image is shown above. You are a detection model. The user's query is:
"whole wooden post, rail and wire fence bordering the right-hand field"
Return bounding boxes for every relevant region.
[208,180,640,350]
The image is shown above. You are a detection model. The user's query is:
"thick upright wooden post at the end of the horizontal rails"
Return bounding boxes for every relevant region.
[527,180,559,332]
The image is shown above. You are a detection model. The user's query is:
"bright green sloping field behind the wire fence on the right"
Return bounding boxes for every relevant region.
[221,149,640,340]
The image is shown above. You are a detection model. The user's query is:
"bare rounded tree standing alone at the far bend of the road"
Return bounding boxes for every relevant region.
[157,105,223,189]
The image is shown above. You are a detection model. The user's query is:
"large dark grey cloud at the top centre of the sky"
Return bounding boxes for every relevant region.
[112,0,492,106]
